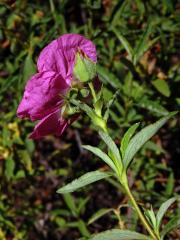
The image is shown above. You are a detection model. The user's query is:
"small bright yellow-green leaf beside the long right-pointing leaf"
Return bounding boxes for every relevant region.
[120,123,139,158]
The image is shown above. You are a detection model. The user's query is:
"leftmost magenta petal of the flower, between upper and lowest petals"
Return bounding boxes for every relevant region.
[17,71,69,121]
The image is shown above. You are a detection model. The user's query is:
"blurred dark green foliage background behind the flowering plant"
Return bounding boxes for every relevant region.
[0,0,180,240]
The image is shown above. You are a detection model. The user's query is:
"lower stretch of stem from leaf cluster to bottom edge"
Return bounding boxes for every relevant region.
[123,184,159,240]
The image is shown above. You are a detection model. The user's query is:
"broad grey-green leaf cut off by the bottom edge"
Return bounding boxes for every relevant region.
[90,229,150,240]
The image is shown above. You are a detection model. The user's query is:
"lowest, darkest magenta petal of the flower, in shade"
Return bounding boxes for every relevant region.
[30,110,68,139]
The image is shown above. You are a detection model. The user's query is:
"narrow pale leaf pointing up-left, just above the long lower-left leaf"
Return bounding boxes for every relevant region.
[82,145,116,171]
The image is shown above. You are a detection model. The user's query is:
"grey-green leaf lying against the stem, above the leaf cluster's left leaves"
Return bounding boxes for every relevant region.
[99,131,122,164]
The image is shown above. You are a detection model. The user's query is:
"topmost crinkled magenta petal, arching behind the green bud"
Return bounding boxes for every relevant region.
[37,33,97,80]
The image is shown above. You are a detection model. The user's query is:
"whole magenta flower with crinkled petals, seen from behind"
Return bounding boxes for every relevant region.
[17,34,97,139]
